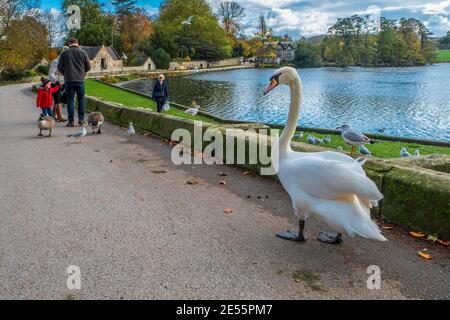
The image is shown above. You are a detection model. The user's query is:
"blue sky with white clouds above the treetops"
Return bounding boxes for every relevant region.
[42,0,450,37]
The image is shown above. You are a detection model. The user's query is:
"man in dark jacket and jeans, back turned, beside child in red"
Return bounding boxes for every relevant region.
[58,38,91,127]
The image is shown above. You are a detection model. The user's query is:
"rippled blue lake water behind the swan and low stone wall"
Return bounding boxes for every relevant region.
[122,64,450,141]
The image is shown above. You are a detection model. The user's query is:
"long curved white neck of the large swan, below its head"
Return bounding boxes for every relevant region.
[279,76,302,155]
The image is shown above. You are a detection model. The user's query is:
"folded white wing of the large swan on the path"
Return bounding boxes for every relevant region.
[286,157,383,201]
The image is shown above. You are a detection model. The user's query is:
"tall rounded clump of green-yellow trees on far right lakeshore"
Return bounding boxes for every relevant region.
[322,15,436,66]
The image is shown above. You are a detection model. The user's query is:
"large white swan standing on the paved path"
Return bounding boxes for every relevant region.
[264,67,386,243]
